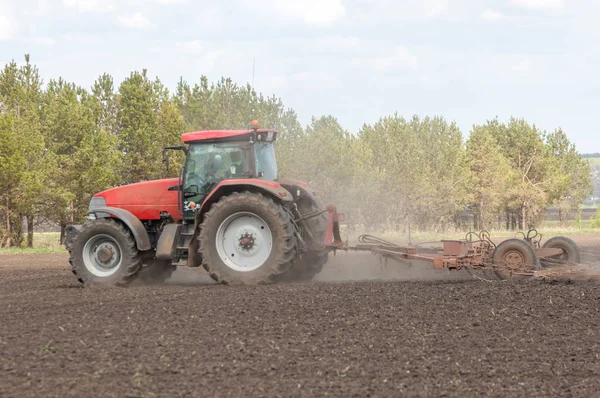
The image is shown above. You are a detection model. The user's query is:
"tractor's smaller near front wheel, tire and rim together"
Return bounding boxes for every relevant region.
[69,218,141,286]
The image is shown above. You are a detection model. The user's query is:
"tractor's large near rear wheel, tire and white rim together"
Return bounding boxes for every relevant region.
[198,192,296,285]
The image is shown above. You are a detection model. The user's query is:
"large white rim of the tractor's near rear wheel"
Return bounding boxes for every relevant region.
[216,212,273,272]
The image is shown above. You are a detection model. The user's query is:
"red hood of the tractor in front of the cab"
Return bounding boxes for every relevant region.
[90,178,181,220]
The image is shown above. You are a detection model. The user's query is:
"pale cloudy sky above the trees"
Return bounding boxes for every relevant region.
[0,0,600,153]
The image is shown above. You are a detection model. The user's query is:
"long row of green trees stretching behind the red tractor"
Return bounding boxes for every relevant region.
[0,56,591,246]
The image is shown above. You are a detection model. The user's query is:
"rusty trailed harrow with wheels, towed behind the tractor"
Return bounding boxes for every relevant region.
[334,225,600,279]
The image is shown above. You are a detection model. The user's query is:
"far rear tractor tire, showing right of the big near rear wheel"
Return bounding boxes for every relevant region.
[282,197,329,282]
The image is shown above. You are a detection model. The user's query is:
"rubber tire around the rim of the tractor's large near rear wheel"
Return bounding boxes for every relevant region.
[198,191,296,285]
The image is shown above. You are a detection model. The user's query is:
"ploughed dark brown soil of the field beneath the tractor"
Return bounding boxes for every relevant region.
[0,235,600,397]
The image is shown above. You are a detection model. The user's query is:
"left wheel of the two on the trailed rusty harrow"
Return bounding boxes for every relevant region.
[492,239,540,279]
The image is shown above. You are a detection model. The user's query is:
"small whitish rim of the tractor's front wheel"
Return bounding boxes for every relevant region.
[83,234,123,277]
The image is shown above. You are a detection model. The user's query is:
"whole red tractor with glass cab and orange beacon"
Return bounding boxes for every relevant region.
[64,121,343,285]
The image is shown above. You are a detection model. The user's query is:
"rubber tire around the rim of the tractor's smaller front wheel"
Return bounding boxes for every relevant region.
[69,218,141,286]
